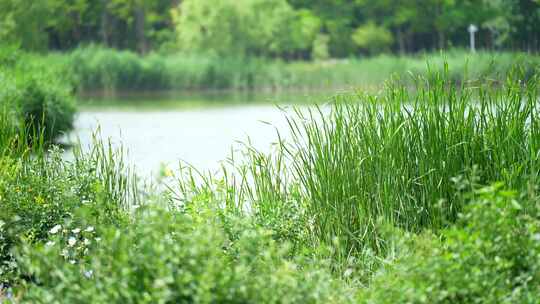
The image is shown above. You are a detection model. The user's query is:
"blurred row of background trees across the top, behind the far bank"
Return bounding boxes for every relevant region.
[0,0,540,59]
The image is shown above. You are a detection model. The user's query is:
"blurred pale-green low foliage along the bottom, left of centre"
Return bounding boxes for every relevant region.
[17,204,350,303]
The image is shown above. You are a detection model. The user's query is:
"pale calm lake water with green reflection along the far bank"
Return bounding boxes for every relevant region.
[65,94,329,176]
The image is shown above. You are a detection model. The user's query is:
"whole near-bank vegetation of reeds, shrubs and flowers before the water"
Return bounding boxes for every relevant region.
[0,54,540,303]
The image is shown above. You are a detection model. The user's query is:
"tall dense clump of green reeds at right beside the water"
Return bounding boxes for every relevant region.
[285,67,540,264]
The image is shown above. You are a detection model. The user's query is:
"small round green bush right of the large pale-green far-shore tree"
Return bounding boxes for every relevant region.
[352,22,394,55]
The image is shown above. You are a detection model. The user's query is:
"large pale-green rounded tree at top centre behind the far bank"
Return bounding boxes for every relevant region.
[173,0,320,56]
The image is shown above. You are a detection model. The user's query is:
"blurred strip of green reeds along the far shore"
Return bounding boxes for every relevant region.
[47,46,540,93]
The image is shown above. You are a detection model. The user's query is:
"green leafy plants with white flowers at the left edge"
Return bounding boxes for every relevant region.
[0,144,133,283]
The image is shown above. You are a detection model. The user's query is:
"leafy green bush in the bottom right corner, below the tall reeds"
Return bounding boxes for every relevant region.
[359,185,540,303]
